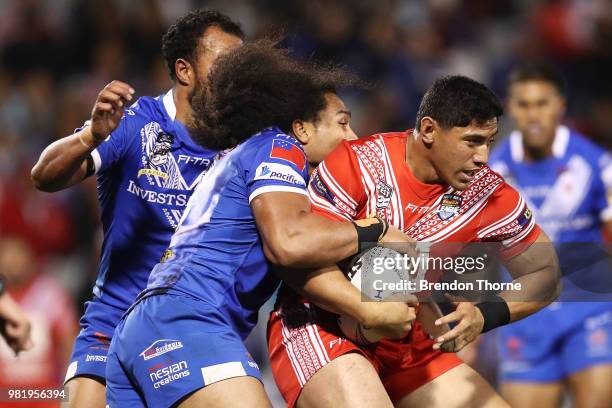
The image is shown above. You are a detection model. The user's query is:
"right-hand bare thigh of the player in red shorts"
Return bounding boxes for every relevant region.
[396,364,508,408]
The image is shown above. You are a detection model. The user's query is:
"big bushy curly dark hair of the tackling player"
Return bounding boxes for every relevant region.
[192,39,365,149]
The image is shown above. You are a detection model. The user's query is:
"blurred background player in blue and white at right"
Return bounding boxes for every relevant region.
[491,64,612,408]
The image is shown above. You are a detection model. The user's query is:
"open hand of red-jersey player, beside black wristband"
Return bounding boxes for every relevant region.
[433,302,484,352]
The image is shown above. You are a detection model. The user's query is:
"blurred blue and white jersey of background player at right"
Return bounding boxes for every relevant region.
[490,126,612,313]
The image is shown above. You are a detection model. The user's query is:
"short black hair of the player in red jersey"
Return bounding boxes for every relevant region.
[415,75,504,130]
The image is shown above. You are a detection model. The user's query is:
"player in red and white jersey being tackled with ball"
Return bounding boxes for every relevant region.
[268,76,559,407]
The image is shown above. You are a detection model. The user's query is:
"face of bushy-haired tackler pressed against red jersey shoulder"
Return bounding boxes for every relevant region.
[304,93,357,167]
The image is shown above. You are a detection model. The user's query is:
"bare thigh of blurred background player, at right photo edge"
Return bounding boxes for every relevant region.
[568,364,612,408]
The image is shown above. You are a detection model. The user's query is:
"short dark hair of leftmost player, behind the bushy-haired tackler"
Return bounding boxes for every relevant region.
[162,9,244,80]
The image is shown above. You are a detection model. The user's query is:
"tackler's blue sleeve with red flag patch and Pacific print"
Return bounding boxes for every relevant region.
[245,133,308,203]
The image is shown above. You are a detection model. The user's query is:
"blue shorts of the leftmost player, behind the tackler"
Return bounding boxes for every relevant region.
[64,299,125,383]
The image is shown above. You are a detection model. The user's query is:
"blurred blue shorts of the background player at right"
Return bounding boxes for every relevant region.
[499,302,612,383]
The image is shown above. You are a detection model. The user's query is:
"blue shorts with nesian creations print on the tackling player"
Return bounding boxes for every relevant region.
[106,292,261,408]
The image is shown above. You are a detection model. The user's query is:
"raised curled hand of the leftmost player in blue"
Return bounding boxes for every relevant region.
[87,81,134,144]
